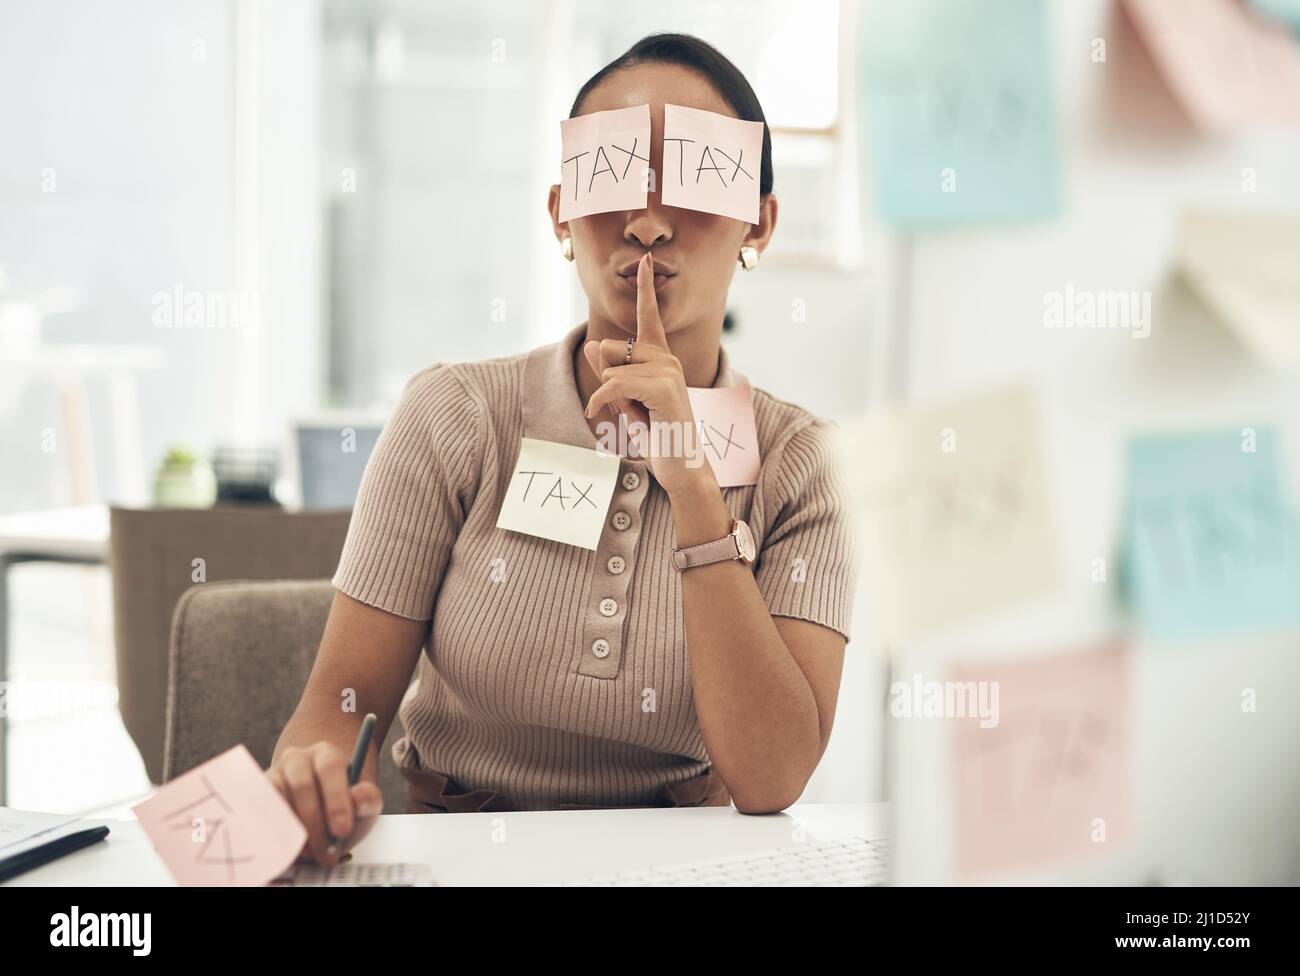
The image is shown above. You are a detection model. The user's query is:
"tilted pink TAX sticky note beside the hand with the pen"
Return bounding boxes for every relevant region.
[133,746,307,885]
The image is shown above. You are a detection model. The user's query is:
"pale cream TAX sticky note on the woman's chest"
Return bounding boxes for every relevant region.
[497,437,619,550]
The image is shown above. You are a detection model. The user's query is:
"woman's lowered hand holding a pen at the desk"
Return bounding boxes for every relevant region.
[267,741,384,868]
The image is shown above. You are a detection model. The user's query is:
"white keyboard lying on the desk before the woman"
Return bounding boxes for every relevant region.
[563,837,889,888]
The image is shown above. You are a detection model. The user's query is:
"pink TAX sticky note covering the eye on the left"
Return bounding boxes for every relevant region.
[560,105,650,224]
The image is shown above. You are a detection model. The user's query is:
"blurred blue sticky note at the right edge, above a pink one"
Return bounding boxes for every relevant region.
[1121,428,1300,641]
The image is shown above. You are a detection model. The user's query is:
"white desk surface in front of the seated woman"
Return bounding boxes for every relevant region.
[4,803,888,888]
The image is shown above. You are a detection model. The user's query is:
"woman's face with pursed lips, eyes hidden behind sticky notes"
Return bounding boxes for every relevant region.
[549,64,776,335]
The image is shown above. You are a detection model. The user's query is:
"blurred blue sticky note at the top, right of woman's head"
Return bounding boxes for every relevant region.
[862,0,1061,227]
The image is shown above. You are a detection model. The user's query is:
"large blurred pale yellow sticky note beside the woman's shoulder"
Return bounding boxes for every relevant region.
[837,387,1060,642]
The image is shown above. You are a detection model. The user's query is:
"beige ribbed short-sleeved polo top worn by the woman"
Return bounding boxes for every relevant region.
[333,324,854,810]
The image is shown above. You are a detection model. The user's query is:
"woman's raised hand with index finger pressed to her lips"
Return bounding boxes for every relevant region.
[582,252,714,496]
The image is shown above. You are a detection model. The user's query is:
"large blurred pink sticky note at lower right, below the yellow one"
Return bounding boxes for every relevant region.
[950,641,1132,879]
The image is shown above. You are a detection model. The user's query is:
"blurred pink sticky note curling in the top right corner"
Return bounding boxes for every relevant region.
[1126,0,1300,133]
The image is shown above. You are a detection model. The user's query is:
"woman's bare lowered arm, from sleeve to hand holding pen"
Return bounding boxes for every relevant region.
[268,593,429,864]
